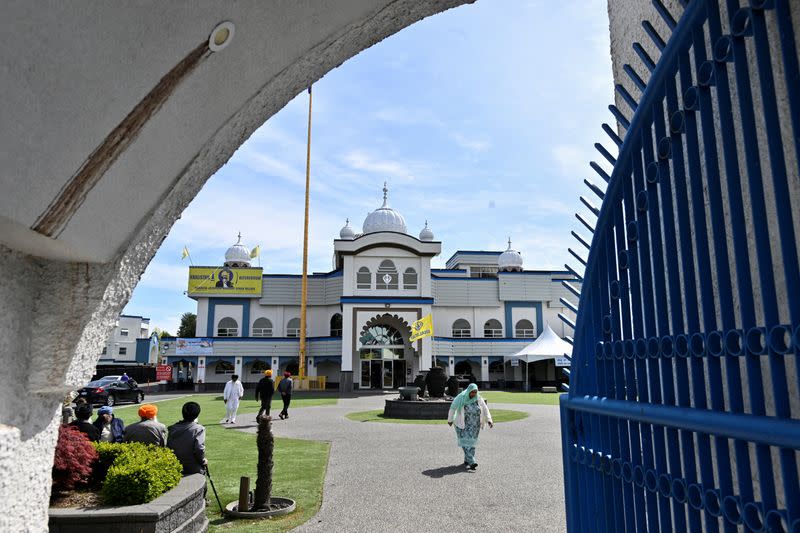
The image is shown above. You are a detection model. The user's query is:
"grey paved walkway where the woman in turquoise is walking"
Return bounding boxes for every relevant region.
[237,396,566,533]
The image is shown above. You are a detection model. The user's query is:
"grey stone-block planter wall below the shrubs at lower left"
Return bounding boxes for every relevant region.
[49,474,208,533]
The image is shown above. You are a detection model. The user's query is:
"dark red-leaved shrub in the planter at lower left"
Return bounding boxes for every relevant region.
[53,424,97,492]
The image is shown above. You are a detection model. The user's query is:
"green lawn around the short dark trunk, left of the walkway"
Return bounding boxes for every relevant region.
[114,394,330,532]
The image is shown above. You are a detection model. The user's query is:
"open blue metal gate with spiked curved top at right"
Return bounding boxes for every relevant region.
[561,0,800,532]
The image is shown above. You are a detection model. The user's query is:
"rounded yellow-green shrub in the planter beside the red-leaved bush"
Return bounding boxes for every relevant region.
[103,444,183,505]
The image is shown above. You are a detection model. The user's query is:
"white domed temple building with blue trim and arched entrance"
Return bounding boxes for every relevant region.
[161,187,577,390]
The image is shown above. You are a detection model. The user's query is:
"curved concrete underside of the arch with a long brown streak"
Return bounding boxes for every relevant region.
[0,0,469,264]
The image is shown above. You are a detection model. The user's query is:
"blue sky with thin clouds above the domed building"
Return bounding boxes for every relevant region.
[124,0,613,334]
